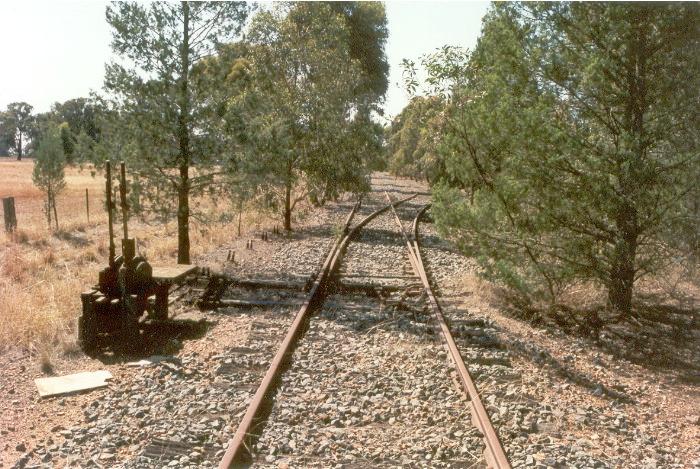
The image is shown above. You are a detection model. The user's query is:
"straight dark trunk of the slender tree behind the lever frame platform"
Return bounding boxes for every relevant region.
[177,2,190,264]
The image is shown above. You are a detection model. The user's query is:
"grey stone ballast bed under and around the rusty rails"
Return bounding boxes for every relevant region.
[4,174,683,469]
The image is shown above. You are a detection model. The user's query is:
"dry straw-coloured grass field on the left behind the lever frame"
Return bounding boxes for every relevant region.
[0,159,265,358]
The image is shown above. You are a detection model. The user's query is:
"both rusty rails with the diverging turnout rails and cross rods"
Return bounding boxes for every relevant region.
[219,188,511,468]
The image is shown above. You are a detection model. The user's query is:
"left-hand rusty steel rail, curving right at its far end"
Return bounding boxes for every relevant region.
[219,194,416,469]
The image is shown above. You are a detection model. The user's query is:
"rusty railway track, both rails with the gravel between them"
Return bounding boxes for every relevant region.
[219,188,510,468]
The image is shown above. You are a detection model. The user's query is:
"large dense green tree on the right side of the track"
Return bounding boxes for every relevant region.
[407,3,700,314]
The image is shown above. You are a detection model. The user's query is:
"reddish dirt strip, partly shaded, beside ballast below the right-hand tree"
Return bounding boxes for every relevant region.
[450,273,700,468]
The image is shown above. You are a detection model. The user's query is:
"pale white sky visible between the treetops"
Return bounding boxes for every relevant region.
[0,0,488,122]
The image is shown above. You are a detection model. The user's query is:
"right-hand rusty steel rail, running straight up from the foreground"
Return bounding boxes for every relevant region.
[386,194,511,469]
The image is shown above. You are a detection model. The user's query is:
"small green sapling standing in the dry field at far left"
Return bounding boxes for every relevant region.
[32,126,66,229]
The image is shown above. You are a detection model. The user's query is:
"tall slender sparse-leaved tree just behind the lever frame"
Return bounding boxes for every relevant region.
[104,2,249,264]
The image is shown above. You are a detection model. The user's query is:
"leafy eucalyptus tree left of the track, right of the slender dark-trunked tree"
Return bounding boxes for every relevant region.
[228,2,372,230]
